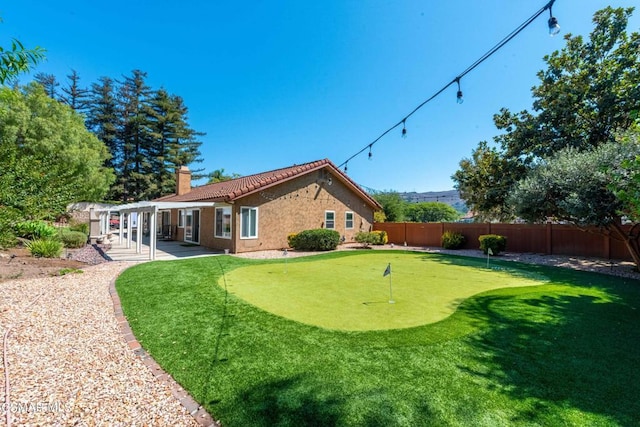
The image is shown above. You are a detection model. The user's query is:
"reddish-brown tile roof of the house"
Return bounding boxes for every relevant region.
[154,159,381,209]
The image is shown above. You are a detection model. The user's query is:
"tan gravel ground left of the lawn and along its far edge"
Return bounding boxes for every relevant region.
[0,245,640,426]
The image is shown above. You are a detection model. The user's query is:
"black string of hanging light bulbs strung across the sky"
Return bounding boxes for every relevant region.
[338,0,560,172]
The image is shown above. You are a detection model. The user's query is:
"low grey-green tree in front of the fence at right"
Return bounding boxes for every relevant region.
[509,142,640,267]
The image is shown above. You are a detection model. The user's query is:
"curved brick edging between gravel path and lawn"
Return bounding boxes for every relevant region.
[109,277,220,427]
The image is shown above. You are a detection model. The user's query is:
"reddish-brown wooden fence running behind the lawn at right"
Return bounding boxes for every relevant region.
[373,222,631,261]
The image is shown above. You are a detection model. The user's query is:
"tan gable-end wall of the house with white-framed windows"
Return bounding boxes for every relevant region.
[232,171,373,252]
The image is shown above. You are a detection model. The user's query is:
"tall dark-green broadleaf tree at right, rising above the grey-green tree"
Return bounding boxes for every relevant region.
[452,7,640,219]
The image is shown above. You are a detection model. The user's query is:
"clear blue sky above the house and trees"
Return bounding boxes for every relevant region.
[0,0,640,192]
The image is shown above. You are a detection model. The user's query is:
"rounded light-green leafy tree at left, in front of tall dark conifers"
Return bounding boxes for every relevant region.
[0,84,114,219]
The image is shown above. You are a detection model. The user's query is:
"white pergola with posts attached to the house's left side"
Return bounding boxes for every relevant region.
[98,202,215,260]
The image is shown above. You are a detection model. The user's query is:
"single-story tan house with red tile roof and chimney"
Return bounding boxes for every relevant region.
[151,159,382,253]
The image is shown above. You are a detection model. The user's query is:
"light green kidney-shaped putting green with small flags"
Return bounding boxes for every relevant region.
[218,251,546,331]
